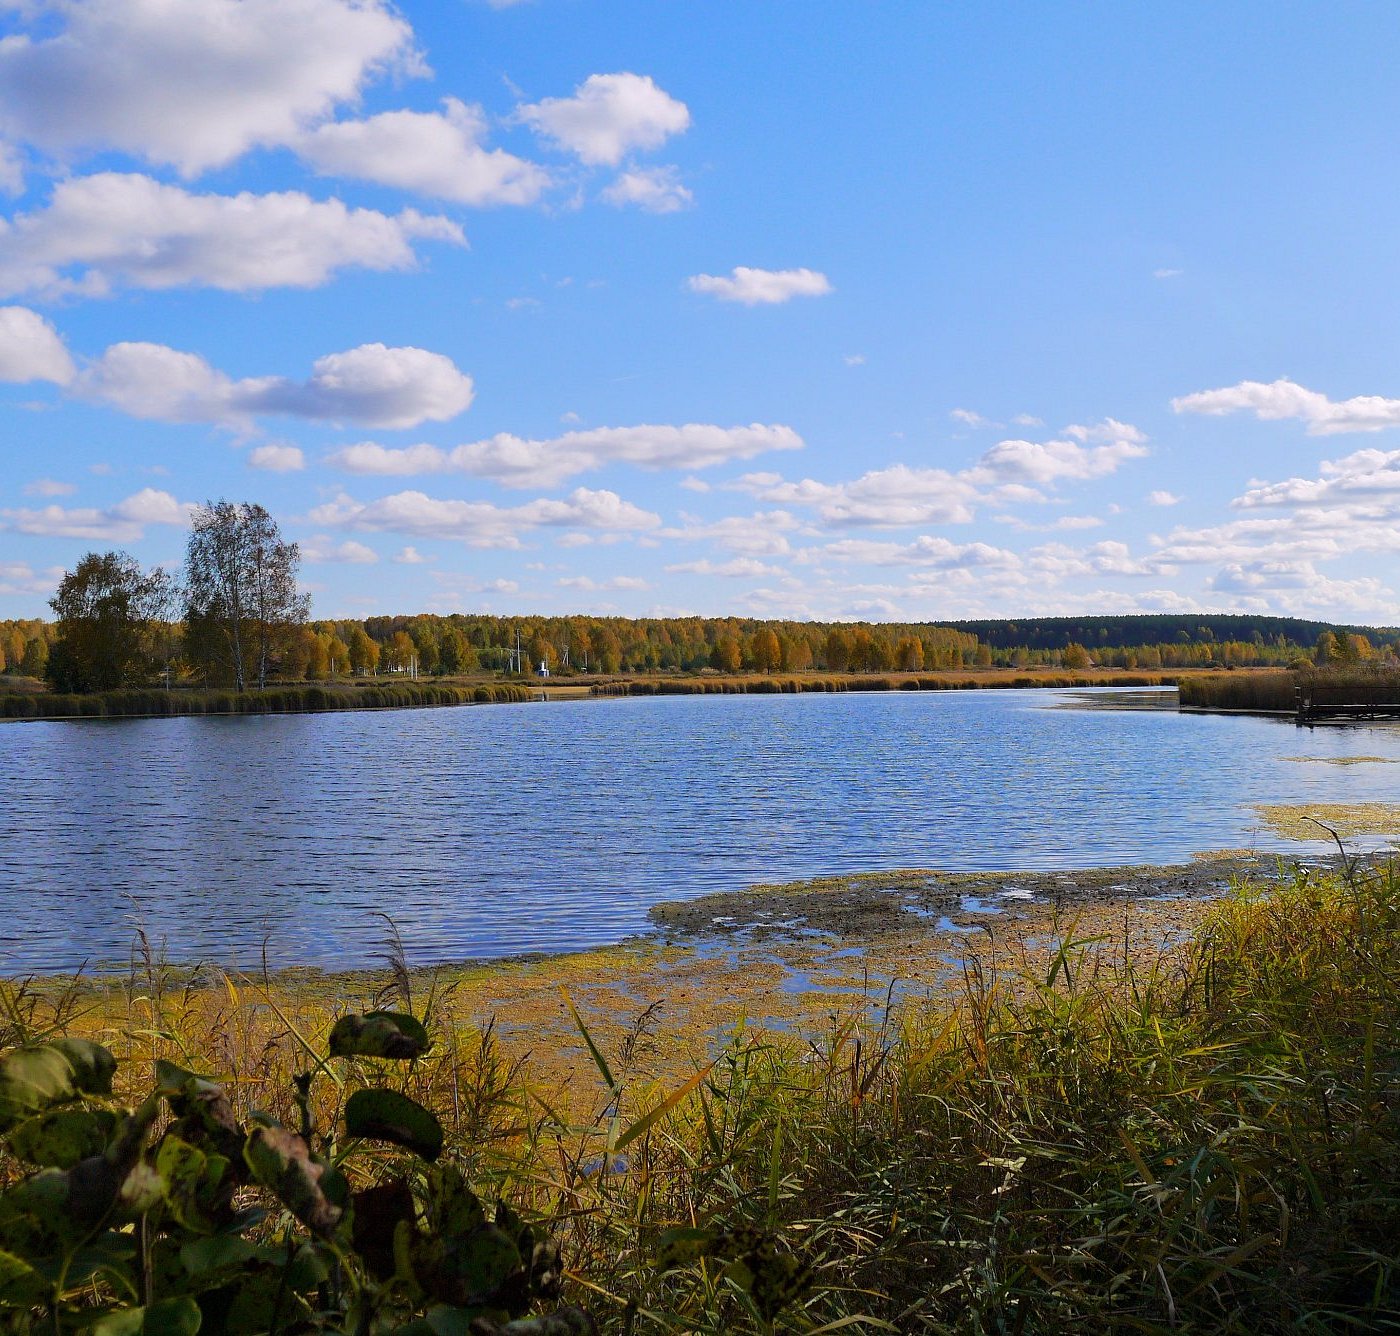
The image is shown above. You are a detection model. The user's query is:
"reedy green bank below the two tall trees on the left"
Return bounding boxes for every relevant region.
[0,682,538,718]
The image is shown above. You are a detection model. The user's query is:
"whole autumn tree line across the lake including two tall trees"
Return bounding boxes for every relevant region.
[0,501,1400,692]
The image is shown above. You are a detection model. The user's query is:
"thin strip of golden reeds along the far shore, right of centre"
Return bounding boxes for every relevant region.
[592,669,1179,696]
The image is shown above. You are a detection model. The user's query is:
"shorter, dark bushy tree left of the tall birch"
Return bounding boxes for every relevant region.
[45,552,160,692]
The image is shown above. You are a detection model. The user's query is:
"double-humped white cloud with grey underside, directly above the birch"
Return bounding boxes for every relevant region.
[81,343,473,428]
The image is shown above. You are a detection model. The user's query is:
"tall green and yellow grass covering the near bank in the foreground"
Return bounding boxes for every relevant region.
[0,868,1400,1333]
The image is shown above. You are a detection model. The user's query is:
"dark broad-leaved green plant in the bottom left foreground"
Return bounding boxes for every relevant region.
[0,1013,596,1336]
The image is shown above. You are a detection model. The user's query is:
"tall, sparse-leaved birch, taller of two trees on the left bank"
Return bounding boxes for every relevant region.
[185,501,311,690]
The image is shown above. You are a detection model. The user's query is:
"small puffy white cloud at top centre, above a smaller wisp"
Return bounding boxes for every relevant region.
[515,73,690,167]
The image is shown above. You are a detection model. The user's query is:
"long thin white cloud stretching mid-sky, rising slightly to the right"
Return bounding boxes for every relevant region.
[326,423,802,487]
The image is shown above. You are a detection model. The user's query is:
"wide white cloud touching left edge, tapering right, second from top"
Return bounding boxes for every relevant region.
[0,172,465,297]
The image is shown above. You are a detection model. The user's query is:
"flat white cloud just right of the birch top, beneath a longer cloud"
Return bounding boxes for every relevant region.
[311,487,661,548]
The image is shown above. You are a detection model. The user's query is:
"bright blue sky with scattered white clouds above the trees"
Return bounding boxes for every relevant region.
[0,0,1400,625]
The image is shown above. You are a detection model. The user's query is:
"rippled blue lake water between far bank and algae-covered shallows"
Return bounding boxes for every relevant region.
[0,690,1400,973]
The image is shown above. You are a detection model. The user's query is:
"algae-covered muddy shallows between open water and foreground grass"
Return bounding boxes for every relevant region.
[11,850,1386,1088]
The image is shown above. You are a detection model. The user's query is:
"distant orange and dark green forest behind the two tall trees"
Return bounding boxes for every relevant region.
[0,613,1400,685]
